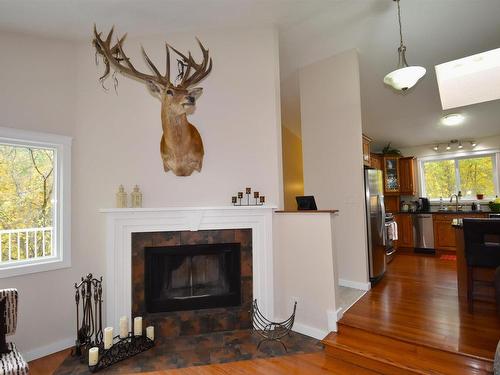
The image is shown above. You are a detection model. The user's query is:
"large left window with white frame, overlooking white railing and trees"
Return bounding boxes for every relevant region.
[0,128,71,277]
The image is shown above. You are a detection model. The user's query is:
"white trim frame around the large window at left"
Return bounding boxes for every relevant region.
[0,127,72,278]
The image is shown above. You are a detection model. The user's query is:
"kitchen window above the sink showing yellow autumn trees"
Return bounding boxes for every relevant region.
[420,153,499,200]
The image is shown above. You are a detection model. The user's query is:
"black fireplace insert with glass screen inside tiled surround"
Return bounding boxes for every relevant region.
[144,243,241,313]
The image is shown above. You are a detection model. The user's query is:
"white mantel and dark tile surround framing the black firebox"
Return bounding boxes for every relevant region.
[101,207,273,338]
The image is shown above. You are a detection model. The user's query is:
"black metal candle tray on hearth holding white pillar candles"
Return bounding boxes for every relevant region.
[87,333,155,373]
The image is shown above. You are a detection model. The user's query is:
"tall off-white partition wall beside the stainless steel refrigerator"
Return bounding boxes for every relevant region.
[300,50,368,284]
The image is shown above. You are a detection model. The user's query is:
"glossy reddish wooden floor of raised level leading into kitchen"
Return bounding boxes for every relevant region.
[341,254,500,359]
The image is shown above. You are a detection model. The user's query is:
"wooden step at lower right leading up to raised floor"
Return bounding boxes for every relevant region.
[323,325,493,375]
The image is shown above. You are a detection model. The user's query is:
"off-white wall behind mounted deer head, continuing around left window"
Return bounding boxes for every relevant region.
[0,29,282,358]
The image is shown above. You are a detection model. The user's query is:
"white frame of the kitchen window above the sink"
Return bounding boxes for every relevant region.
[417,149,500,203]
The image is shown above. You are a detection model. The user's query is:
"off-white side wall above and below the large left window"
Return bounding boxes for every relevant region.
[0,33,77,362]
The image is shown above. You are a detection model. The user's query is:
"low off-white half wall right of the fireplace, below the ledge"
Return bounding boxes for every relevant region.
[273,213,338,340]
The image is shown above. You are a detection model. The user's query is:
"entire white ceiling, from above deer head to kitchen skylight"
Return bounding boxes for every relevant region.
[0,0,500,147]
